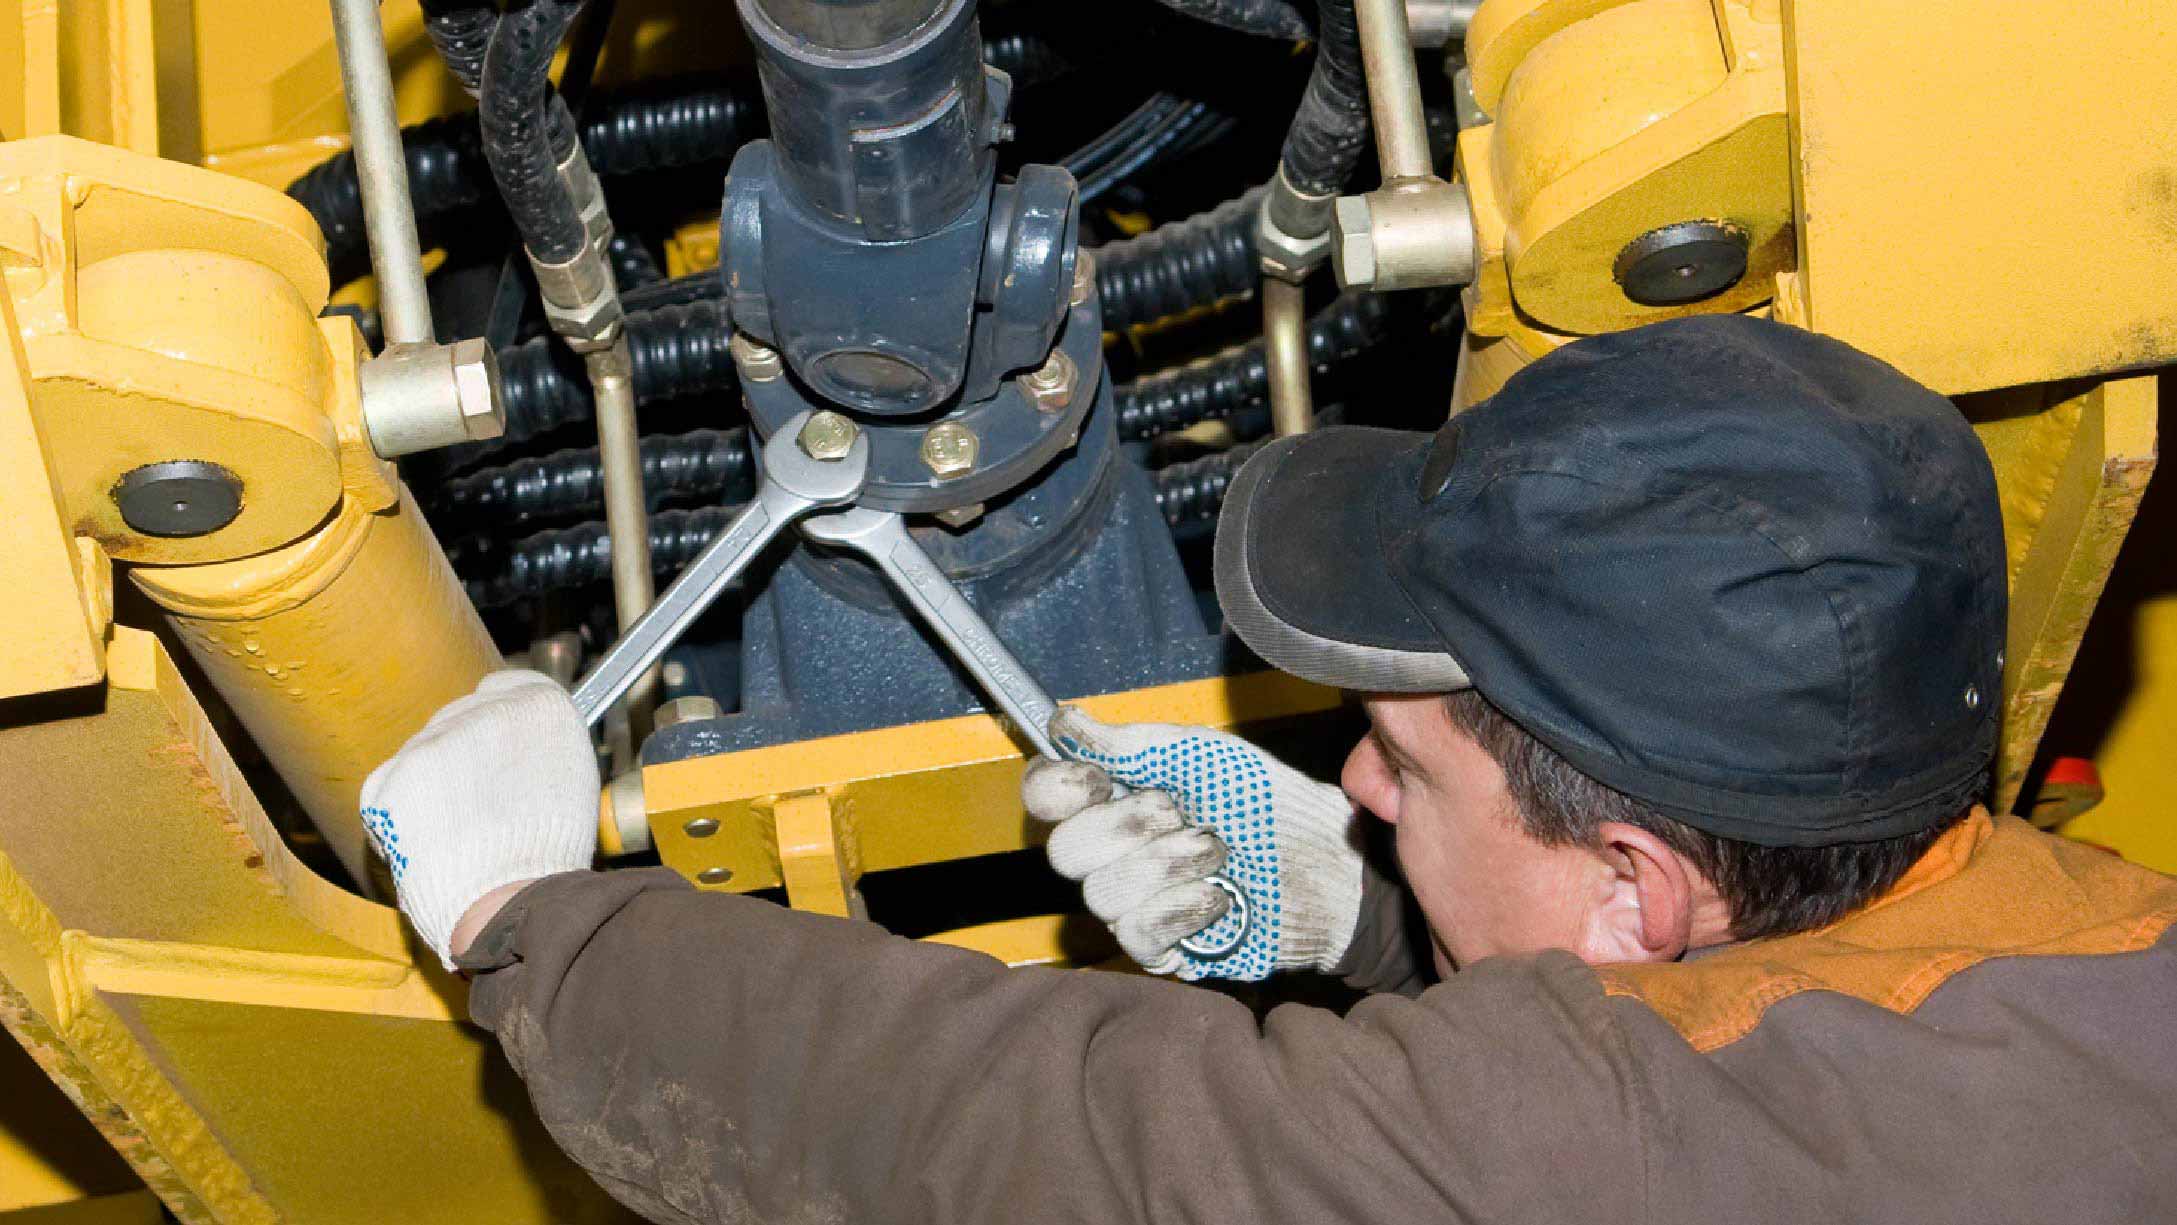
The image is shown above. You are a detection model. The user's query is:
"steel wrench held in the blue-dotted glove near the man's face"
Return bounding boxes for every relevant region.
[801,509,1254,960]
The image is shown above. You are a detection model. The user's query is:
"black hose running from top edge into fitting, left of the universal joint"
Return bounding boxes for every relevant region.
[477,0,583,263]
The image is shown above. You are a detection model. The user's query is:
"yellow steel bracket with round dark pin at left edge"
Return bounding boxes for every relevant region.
[0,137,396,578]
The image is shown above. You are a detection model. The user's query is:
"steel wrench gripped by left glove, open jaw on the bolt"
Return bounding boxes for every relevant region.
[575,413,869,727]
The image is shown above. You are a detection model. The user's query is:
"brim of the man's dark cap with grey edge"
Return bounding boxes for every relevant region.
[1217,426,1472,694]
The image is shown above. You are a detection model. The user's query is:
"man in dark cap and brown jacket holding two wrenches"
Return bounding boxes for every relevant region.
[366,318,2177,1223]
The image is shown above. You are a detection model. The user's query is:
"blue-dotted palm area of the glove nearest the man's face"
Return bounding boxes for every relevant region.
[1058,735,1282,981]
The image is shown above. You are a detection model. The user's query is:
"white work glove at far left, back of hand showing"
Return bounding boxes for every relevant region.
[364,672,596,970]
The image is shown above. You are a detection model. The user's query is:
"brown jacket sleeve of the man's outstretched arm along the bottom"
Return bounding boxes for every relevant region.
[464,868,1648,1225]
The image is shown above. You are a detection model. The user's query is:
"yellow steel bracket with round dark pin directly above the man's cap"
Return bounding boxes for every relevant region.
[1459,0,1794,335]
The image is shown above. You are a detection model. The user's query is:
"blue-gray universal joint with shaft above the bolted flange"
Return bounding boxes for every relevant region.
[721,0,1080,416]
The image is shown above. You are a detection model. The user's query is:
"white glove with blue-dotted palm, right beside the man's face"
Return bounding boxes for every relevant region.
[1021,707,1361,981]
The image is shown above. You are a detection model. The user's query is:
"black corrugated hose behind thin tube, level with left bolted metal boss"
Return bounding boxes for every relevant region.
[496,298,738,446]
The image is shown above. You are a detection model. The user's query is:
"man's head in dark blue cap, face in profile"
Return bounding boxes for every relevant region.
[1217,315,2005,979]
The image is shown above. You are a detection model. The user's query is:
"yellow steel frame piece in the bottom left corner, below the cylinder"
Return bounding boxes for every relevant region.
[0,629,627,1225]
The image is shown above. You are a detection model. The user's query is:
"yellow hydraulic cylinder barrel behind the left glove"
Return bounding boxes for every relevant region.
[131,490,499,892]
